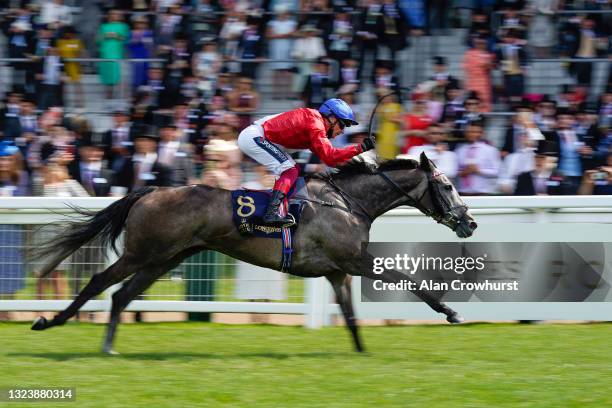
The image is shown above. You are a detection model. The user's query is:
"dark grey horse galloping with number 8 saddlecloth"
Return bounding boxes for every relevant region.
[32,154,476,353]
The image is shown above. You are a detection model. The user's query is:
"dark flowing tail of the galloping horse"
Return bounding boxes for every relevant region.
[34,187,157,277]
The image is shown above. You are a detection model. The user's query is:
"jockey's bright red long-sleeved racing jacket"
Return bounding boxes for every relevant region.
[261,108,362,167]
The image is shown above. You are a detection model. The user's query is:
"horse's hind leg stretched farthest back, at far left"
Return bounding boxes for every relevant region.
[32,257,133,330]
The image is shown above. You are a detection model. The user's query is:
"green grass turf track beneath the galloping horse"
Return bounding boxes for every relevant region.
[0,322,612,408]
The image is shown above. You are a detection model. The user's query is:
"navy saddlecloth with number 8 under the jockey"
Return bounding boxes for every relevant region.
[232,177,309,238]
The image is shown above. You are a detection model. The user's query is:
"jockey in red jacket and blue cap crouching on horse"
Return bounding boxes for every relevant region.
[238,99,374,227]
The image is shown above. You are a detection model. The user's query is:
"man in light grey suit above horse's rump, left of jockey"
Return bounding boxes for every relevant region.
[157,124,193,186]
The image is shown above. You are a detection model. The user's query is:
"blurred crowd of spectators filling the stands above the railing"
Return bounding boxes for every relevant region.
[0,0,612,204]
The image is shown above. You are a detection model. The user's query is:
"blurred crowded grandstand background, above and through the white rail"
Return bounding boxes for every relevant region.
[0,0,612,326]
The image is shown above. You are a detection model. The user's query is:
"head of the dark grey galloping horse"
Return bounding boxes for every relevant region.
[419,153,478,238]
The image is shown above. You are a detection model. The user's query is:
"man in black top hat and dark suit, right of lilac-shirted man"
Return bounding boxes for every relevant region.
[514,140,565,196]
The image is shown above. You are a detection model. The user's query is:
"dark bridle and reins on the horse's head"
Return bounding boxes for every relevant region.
[376,171,467,231]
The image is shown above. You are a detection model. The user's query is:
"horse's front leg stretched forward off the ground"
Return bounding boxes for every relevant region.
[344,254,464,323]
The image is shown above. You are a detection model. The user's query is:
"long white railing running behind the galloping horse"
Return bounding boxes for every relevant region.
[0,196,612,327]
